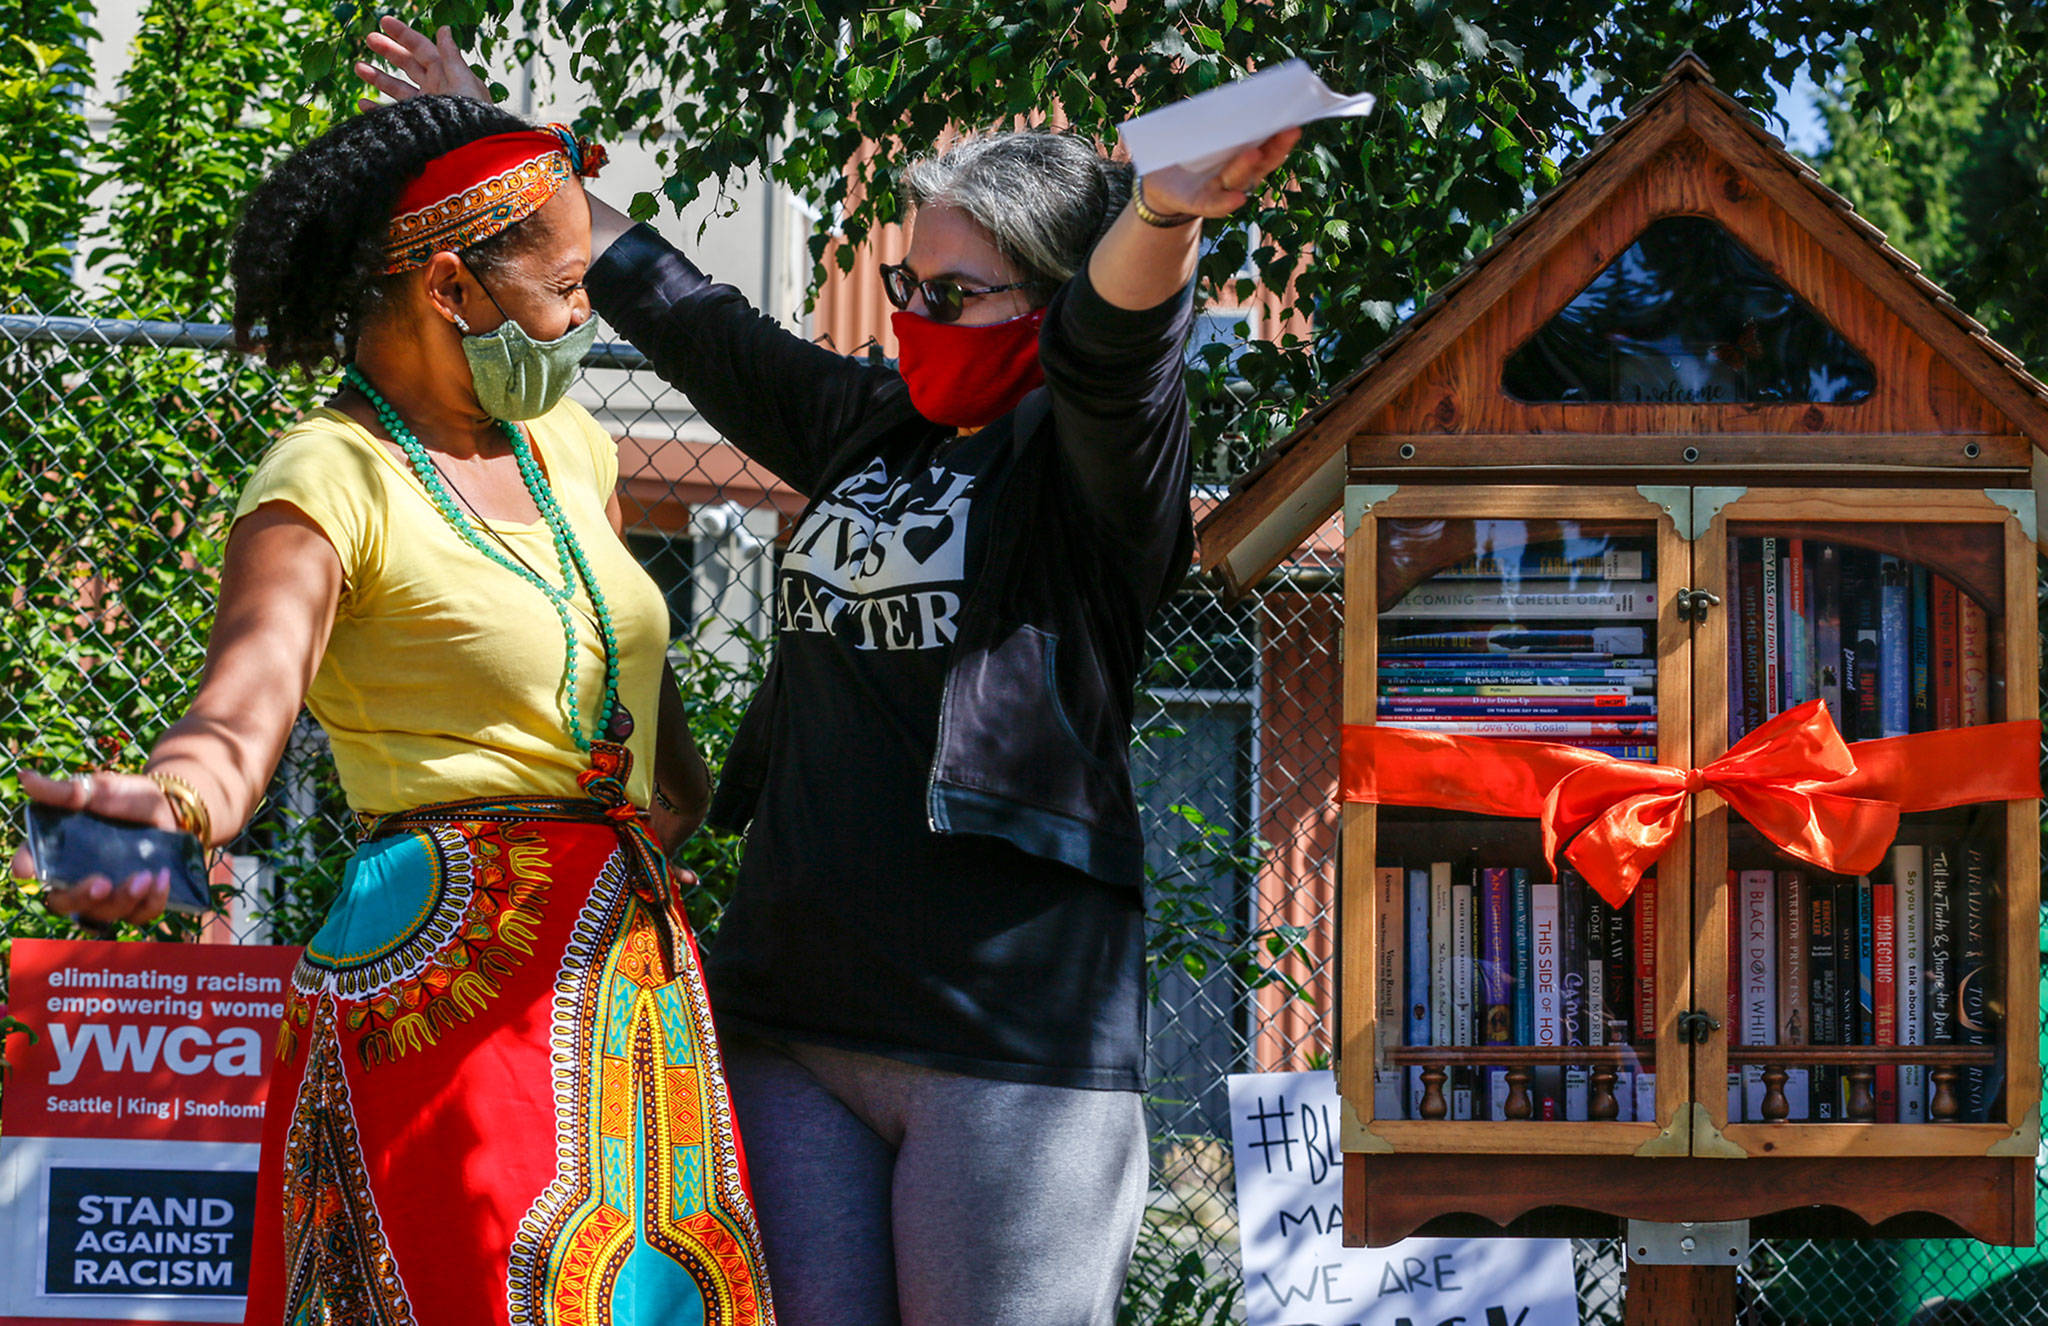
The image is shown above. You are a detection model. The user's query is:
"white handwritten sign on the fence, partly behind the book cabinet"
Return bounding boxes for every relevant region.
[1231,1072,1579,1326]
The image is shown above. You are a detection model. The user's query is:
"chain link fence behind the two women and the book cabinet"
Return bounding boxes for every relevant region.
[0,295,2048,1326]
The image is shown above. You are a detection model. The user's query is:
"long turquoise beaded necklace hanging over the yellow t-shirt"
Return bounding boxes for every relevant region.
[346,365,633,754]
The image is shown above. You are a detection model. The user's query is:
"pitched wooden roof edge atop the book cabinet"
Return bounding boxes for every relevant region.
[1198,51,2048,594]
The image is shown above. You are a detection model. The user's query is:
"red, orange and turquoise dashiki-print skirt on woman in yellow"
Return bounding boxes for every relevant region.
[248,801,774,1326]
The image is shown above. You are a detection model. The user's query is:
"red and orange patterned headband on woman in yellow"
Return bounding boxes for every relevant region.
[385,125,604,275]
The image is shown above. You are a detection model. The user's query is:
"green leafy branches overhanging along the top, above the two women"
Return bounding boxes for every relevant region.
[313,0,2040,457]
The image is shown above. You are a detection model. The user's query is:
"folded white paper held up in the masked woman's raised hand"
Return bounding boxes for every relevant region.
[1116,59,1372,174]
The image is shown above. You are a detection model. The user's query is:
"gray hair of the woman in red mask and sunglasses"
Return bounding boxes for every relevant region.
[903,129,1130,291]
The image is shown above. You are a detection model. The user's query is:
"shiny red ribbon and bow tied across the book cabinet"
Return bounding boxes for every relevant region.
[1339,701,2042,906]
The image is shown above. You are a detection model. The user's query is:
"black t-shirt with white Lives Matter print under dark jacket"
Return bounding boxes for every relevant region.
[707,418,1145,1090]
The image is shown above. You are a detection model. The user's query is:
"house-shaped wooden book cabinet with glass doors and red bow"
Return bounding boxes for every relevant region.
[1200,55,2048,1278]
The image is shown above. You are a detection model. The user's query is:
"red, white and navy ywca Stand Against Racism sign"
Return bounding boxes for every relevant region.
[0,939,299,1326]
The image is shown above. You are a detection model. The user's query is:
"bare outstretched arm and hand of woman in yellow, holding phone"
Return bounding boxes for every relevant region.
[14,502,342,922]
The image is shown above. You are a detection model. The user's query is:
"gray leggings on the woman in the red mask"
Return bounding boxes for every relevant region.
[725,1037,1147,1326]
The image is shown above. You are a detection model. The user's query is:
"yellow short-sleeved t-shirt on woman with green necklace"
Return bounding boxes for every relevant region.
[236,400,668,814]
